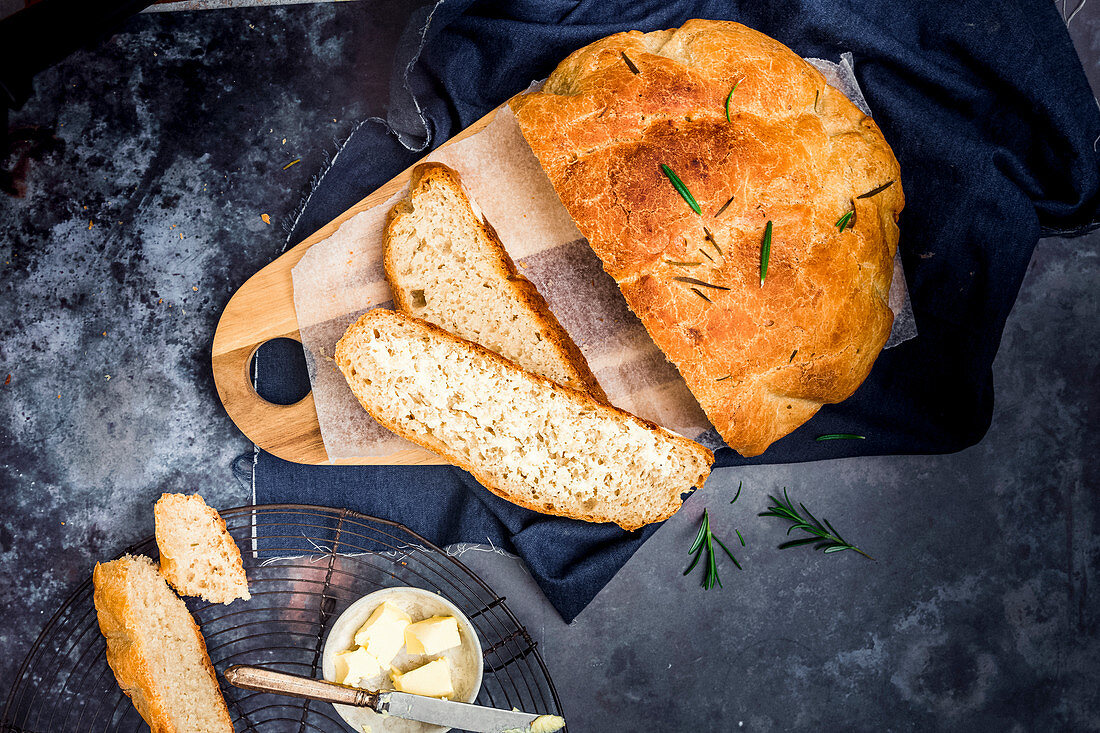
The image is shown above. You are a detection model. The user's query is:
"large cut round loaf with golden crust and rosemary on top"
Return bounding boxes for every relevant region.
[512,20,904,456]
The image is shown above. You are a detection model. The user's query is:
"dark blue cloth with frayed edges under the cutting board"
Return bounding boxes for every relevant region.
[255,0,1100,620]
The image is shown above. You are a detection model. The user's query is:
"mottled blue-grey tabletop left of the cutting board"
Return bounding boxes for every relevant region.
[0,2,410,697]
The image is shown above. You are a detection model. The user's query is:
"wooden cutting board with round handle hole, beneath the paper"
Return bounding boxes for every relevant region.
[211,102,507,464]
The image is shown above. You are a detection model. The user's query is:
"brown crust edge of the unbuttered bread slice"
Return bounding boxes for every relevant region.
[382,163,611,404]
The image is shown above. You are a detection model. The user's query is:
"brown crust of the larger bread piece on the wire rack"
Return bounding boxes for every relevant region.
[91,555,233,733]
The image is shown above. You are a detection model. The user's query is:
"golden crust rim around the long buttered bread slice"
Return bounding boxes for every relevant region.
[333,308,714,532]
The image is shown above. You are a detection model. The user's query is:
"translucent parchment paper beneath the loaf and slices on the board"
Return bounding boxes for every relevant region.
[292,54,916,460]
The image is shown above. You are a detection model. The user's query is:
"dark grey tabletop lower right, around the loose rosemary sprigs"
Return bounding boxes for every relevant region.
[465,226,1100,731]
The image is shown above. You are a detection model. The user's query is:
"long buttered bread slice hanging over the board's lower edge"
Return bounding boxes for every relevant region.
[336,309,714,529]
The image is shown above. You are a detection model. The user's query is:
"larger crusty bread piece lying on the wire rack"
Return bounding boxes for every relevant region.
[92,555,233,733]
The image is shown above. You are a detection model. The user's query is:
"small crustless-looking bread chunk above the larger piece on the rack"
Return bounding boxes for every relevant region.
[153,494,252,603]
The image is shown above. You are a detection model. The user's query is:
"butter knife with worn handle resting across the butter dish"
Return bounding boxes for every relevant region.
[226,665,565,733]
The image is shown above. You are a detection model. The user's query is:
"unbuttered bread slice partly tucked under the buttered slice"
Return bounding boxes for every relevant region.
[382,163,607,403]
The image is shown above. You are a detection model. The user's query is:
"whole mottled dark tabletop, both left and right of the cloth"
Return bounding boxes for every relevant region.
[0,2,1100,731]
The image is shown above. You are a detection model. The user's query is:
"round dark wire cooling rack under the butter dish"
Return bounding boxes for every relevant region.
[0,504,563,733]
